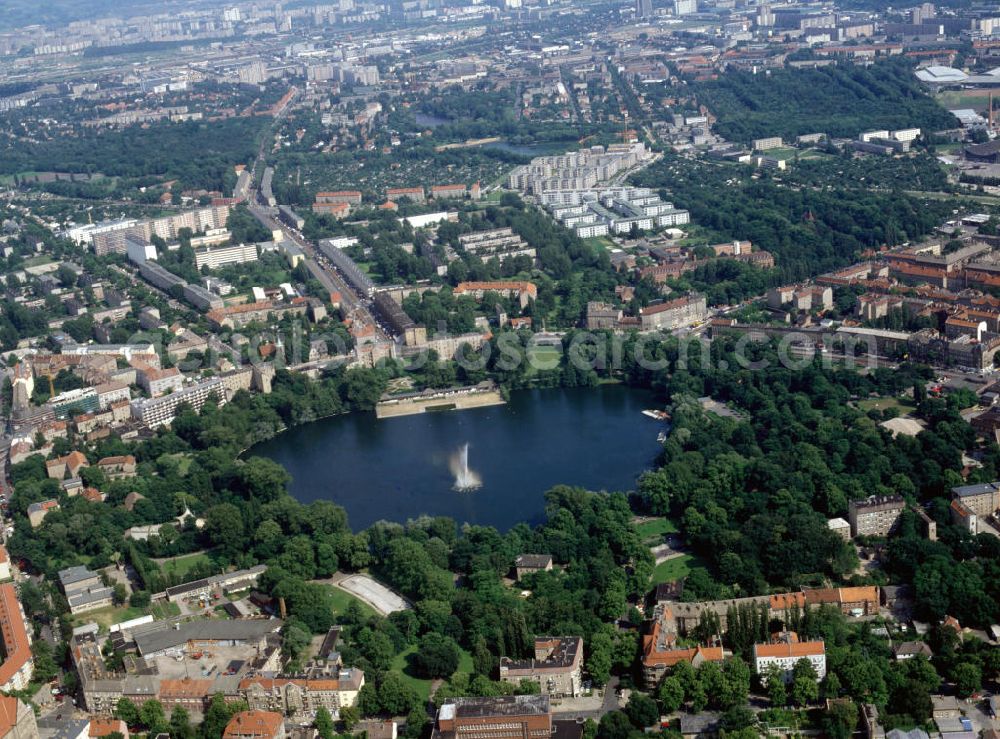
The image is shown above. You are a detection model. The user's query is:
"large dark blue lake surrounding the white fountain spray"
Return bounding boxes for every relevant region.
[249,385,667,531]
